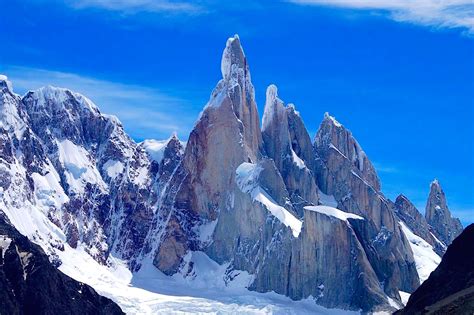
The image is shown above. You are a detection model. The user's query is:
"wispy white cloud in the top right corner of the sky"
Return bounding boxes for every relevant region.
[289,0,474,33]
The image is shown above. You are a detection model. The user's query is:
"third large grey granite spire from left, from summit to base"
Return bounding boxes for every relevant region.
[314,114,419,296]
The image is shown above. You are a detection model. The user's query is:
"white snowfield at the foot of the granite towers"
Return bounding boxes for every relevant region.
[59,245,358,314]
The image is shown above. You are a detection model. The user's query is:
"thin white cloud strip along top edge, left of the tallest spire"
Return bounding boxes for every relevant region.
[66,0,203,14]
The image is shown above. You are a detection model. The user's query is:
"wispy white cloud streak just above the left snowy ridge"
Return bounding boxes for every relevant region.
[1,66,200,139]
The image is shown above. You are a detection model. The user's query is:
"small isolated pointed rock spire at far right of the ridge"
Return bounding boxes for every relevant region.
[425,179,462,245]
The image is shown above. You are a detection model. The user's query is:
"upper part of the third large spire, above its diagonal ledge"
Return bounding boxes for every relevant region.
[314,113,380,191]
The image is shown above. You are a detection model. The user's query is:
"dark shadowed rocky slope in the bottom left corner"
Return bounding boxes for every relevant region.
[0,211,124,314]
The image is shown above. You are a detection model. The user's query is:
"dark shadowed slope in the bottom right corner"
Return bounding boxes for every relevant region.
[399,224,474,314]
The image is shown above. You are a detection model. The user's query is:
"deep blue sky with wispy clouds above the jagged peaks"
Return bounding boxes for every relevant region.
[0,0,474,224]
